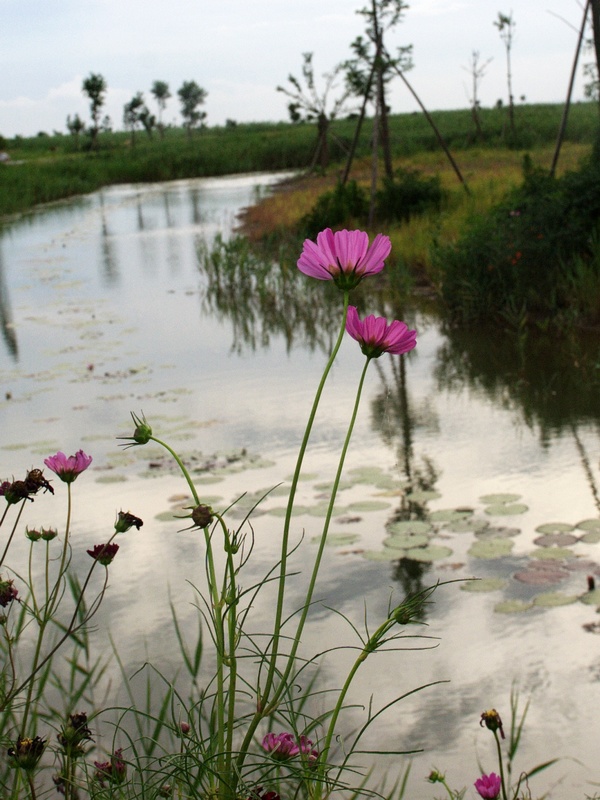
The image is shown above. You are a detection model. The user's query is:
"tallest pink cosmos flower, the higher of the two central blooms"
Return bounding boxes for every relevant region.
[298,228,392,290]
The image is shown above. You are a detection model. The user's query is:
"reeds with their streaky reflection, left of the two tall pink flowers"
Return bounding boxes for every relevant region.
[198,236,341,353]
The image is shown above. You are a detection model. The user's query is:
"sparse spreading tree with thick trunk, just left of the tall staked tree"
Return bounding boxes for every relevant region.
[277,53,351,169]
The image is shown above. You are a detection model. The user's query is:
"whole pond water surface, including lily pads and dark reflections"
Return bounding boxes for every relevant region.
[0,175,600,800]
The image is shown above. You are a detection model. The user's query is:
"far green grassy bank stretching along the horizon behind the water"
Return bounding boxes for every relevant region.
[0,103,598,222]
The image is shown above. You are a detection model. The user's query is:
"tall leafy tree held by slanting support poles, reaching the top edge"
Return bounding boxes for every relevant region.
[345,0,412,178]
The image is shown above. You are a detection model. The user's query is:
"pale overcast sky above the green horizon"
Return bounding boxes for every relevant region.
[0,0,591,136]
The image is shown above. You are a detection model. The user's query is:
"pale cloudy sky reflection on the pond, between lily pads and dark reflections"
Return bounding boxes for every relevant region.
[0,178,600,798]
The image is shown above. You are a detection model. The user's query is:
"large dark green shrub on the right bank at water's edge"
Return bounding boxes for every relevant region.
[433,153,600,320]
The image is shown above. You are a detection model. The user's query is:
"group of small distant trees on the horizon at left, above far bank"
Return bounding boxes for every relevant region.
[67,72,208,150]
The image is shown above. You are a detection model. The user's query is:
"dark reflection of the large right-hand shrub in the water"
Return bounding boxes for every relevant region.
[435,320,600,444]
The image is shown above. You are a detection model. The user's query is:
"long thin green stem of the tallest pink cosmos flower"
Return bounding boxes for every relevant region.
[232,291,350,774]
